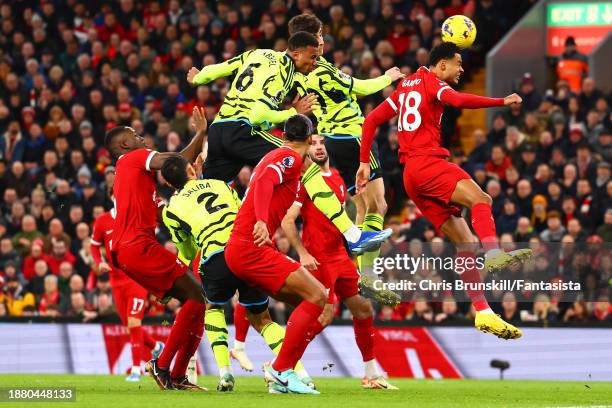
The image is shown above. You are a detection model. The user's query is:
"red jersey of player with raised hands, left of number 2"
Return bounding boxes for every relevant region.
[112,149,157,250]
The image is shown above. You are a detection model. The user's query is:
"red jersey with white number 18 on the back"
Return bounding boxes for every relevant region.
[386,67,450,162]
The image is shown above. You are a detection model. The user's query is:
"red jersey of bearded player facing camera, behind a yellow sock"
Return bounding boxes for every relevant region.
[295,169,348,261]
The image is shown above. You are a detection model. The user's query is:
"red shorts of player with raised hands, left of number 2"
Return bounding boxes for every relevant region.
[113,239,189,299]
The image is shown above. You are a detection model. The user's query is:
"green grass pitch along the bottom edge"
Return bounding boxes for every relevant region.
[0,374,612,408]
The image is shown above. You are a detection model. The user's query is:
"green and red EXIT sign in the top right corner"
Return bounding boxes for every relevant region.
[546,1,612,56]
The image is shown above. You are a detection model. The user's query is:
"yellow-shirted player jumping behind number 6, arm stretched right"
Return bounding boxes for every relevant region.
[288,14,404,278]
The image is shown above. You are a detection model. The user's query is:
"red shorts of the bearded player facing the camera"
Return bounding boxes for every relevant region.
[312,257,359,304]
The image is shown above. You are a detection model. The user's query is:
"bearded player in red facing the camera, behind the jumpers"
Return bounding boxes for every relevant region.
[282,135,397,390]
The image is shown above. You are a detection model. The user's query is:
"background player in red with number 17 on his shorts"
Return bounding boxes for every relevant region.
[91,209,164,382]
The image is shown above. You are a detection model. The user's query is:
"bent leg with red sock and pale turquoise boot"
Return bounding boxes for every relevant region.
[266,267,327,394]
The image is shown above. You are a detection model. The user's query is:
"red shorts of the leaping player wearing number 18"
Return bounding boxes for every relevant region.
[404,156,471,229]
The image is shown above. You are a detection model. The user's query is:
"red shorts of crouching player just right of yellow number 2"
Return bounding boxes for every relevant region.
[225,243,301,295]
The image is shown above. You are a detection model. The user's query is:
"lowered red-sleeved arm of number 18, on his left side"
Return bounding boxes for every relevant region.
[355,98,397,193]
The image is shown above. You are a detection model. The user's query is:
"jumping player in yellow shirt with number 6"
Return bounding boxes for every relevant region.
[187,31,390,254]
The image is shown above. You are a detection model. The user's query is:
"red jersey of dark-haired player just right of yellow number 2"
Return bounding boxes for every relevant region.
[230,146,302,244]
